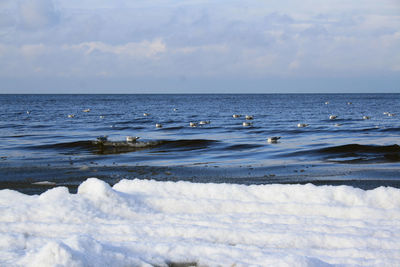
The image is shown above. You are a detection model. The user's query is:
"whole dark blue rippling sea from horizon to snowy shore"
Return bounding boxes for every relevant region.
[0,94,400,193]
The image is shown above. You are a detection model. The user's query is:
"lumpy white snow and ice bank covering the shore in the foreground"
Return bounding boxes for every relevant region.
[0,178,400,267]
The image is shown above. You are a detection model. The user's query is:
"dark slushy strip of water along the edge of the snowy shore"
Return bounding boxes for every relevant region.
[0,164,400,195]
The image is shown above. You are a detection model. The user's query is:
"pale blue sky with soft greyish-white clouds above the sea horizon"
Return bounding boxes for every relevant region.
[0,0,400,93]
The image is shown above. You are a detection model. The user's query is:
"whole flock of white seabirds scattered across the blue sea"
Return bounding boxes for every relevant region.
[26,101,396,147]
